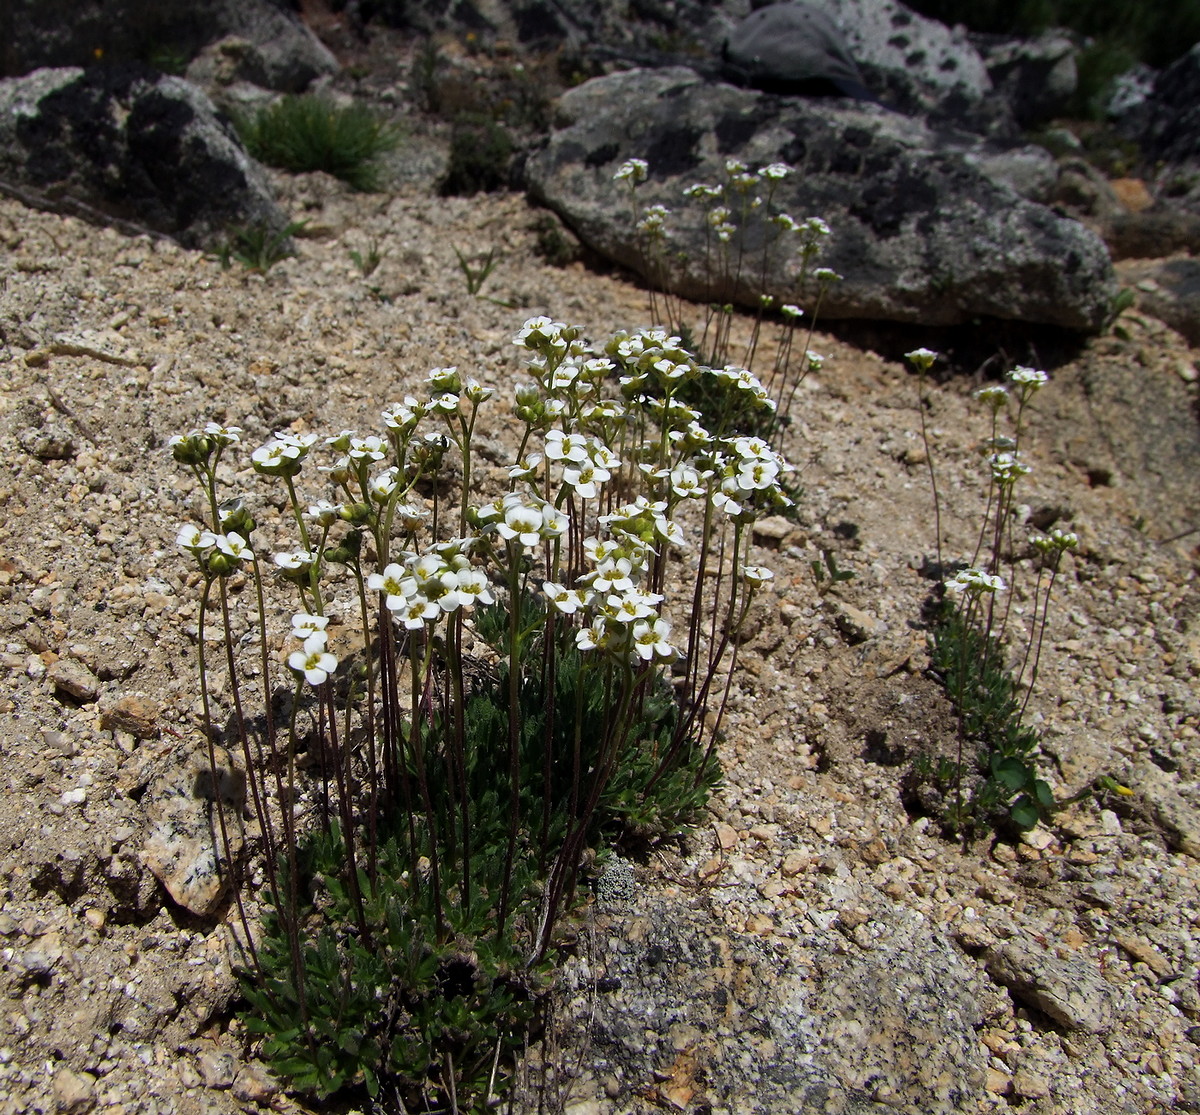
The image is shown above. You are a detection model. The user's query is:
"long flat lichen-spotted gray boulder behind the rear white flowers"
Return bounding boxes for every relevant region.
[526,67,1116,330]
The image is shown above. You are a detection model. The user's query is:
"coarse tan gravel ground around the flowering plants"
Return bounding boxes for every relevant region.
[0,140,1200,1115]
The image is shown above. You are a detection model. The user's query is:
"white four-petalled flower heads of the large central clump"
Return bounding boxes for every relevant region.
[172,317,792,685]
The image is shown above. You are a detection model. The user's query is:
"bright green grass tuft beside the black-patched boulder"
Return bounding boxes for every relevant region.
[236,95,400,191]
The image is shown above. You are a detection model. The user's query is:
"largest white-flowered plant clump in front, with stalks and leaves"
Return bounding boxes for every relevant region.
[172,318,791,1108]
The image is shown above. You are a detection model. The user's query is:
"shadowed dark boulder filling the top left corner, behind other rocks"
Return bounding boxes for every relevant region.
[0,0,338,92]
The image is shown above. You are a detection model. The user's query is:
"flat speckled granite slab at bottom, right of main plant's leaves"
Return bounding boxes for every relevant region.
[556,893,985,1115]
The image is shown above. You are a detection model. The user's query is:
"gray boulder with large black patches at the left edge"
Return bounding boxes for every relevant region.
[0,66,287,247]
